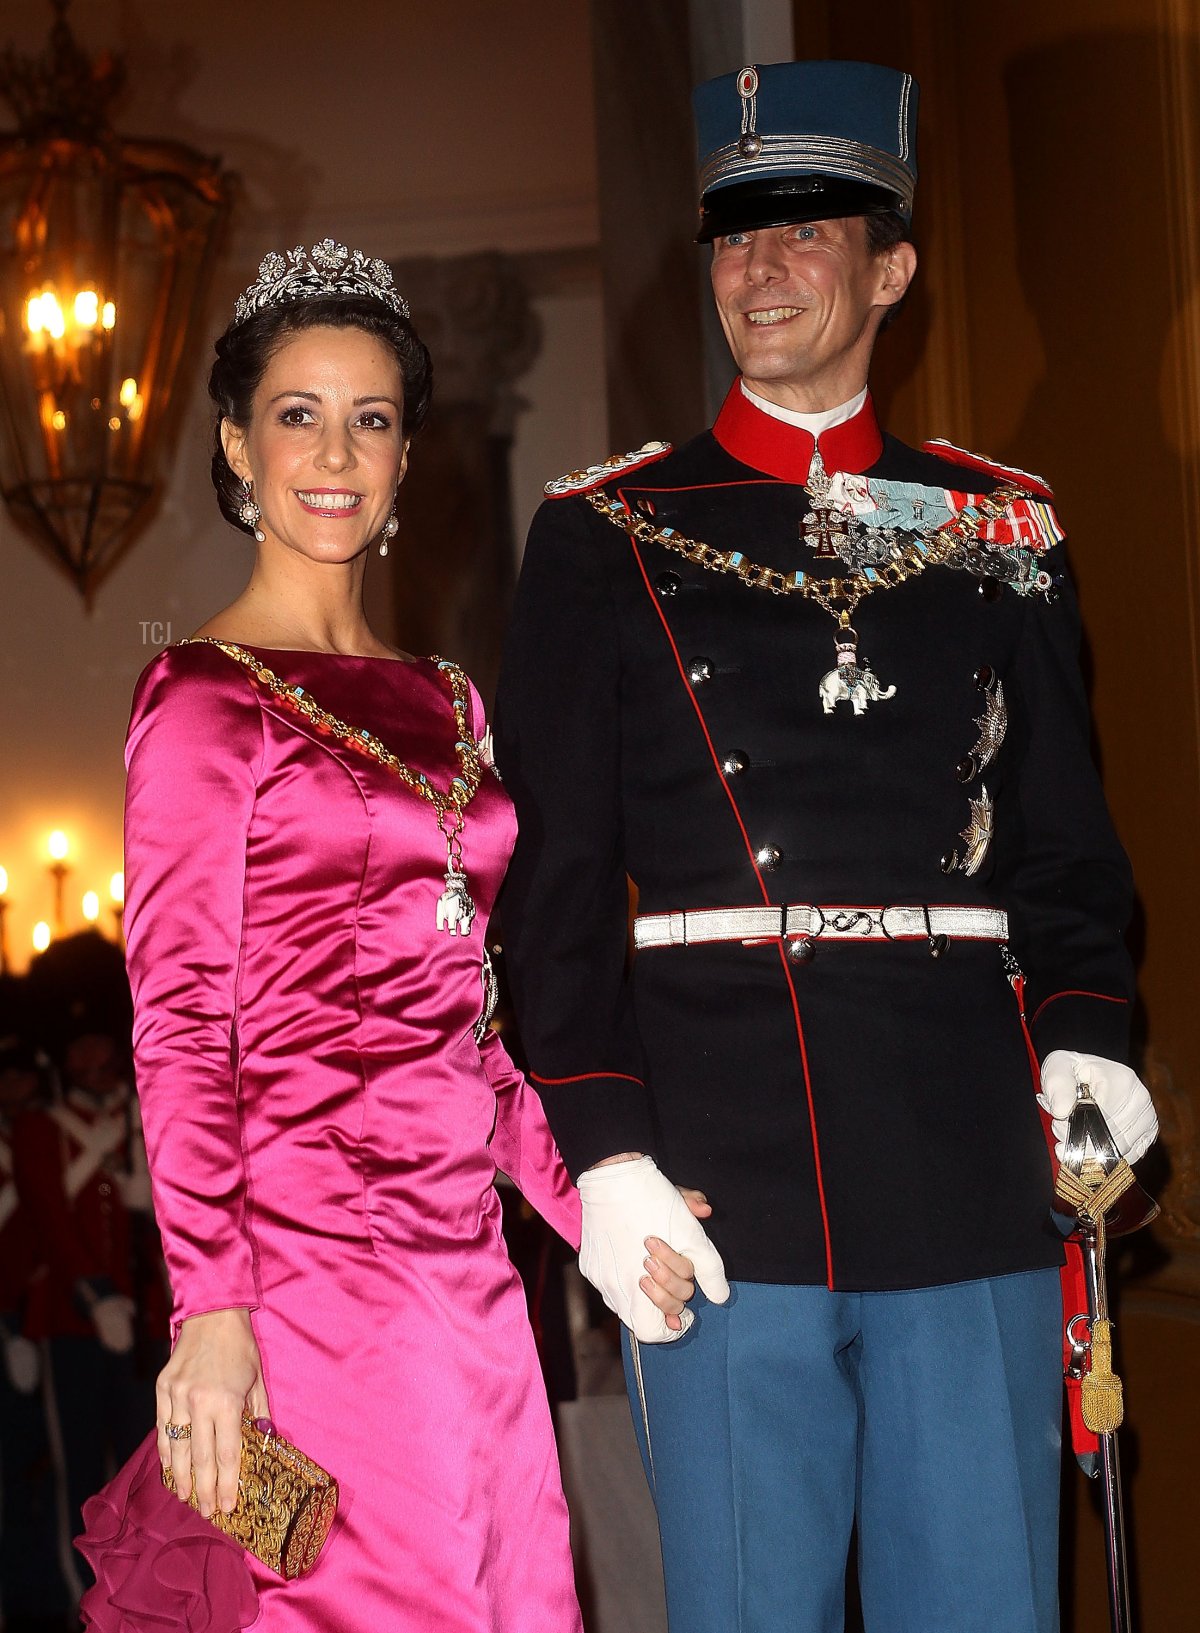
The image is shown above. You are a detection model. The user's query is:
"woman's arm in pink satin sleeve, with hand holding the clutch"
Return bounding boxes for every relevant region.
[126,647,266,1514]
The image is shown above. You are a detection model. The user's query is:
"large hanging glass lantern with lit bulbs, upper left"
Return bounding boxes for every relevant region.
[0,0,232,604]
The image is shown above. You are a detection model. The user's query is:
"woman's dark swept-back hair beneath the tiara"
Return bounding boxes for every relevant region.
[209,296,433,534]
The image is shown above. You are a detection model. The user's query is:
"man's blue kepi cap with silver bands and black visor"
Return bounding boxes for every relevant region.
[692,62,918,243]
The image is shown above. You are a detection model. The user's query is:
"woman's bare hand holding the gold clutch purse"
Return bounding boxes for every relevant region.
[155,1310,271,1519]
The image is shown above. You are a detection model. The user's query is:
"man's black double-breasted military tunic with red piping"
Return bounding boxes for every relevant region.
[496,387,1131,1290]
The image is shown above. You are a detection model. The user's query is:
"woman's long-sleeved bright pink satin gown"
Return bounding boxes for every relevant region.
[126,645,581,1633]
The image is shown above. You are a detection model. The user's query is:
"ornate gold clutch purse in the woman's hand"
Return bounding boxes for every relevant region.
[163,1417,338,1579]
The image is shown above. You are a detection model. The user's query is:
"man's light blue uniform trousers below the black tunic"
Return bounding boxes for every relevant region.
[625,1270,1063,1633]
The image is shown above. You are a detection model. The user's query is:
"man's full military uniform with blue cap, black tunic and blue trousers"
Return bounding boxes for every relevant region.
[495,62,1144,1633]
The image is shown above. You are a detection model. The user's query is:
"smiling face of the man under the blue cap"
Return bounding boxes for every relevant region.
[712,216,916,412]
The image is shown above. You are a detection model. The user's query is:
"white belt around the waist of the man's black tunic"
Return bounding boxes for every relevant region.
[633,903,1009,949]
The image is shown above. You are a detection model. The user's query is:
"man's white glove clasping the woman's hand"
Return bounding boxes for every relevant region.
[580,1156,730,1344]
